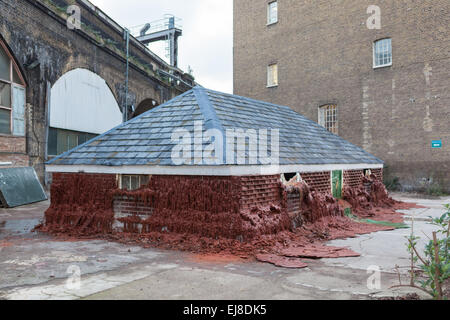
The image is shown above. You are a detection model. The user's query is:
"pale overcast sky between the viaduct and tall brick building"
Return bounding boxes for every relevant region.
[90,0,233,93]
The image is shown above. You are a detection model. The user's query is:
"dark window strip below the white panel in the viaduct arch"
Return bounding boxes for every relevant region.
[48,128,97,156]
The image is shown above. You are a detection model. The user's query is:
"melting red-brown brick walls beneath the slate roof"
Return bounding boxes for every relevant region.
[46,170,382,238]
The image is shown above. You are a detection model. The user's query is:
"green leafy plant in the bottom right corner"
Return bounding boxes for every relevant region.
[394,204,450,300]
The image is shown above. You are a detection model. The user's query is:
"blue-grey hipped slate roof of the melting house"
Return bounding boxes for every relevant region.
[48,87,383,166]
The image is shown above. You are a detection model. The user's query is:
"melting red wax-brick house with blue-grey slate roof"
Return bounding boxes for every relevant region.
[46,87,383,239]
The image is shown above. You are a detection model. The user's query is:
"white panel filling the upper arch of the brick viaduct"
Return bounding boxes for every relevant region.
[50,69,122,134]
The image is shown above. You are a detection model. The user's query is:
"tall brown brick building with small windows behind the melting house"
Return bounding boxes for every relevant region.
[234,0,450,192]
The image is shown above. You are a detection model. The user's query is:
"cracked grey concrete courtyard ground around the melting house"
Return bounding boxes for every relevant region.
[0,194,450,300]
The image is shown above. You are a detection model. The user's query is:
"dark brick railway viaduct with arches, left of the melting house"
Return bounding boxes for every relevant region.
[0,0,194,181]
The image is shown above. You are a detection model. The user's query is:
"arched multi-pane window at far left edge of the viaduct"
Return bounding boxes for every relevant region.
[0,40,25,136]
